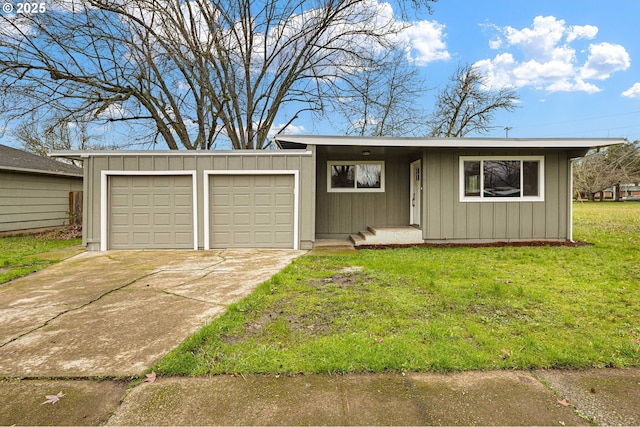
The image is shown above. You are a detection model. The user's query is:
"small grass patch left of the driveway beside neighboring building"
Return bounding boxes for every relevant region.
[0,232,82,283]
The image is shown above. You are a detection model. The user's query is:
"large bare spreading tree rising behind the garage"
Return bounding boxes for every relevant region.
[0,0,432,149]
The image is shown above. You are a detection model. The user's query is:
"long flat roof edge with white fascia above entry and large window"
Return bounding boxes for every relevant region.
[275,135,626,149]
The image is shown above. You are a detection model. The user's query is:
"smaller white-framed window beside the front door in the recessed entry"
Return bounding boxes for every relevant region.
[327,161,384,192]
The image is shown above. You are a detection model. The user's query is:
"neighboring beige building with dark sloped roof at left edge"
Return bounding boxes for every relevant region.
[0,145,83,234]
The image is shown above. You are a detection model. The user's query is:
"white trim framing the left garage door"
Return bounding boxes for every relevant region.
[100,170,198,251]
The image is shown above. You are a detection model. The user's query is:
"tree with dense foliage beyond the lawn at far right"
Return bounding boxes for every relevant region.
[573,141,640,200]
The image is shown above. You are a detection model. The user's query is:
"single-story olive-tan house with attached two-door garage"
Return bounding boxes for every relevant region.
[53,135,624,250]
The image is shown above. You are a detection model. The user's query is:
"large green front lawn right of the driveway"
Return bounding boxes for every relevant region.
[154,203,640,375]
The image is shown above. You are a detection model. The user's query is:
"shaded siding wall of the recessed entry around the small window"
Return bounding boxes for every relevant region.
[316,147,412,239]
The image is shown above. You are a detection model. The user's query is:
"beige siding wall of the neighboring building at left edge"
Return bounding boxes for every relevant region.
[0,171,82,232]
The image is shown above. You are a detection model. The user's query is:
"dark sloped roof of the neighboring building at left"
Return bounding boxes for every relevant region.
[0,144,82,177]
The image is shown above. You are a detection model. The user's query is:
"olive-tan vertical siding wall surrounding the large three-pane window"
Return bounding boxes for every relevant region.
[423,150,571,242]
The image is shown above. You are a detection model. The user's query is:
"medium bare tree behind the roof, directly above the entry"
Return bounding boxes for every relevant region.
[333,50,427,136]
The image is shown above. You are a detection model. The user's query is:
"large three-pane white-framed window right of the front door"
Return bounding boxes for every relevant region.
[460,156,544,202]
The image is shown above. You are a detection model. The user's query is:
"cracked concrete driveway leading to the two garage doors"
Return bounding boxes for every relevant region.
[0,249,305,378]
